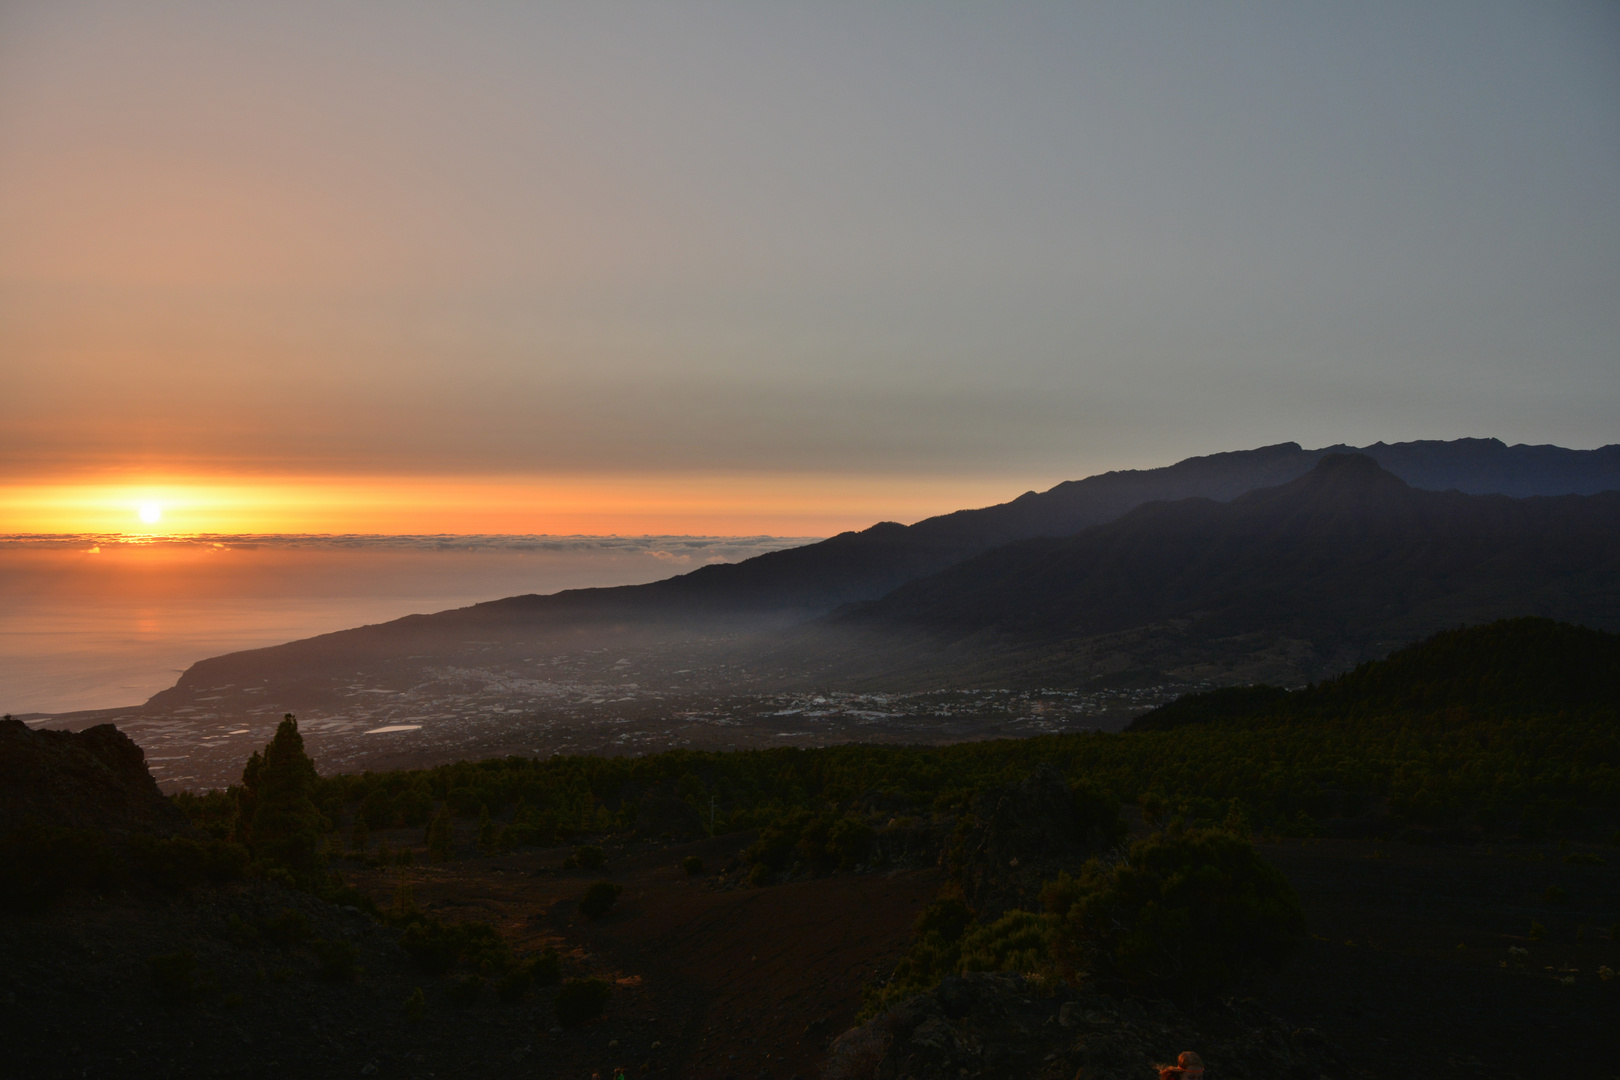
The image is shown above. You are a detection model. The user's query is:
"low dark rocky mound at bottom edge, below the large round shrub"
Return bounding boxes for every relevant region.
[825,973,1346,1080]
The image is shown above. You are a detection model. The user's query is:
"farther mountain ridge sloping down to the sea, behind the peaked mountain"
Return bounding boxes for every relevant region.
[152,439,1620,706]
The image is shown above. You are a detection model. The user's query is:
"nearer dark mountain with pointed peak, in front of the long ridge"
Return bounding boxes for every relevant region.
[800,455,1620,689]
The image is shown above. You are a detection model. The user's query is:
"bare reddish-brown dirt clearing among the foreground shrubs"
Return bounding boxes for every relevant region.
[355,834,943,1080]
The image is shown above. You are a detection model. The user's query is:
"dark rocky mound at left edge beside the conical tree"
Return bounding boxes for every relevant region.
[0,719,190,836]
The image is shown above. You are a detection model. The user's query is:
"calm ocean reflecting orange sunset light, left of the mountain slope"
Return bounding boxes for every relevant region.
[0,536,818,714]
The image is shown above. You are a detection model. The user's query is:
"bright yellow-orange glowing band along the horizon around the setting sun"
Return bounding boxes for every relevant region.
[0,474,1022,536]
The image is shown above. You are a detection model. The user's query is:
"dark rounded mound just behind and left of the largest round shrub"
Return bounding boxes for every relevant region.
[962,764,1108,921]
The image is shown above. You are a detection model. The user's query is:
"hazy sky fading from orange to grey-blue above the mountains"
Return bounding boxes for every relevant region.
[0,0,1620,533]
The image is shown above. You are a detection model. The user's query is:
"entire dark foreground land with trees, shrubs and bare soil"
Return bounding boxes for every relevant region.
[0,619,1620,1080]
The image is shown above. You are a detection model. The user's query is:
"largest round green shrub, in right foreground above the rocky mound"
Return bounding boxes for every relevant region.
[1042,829,1304,996]
